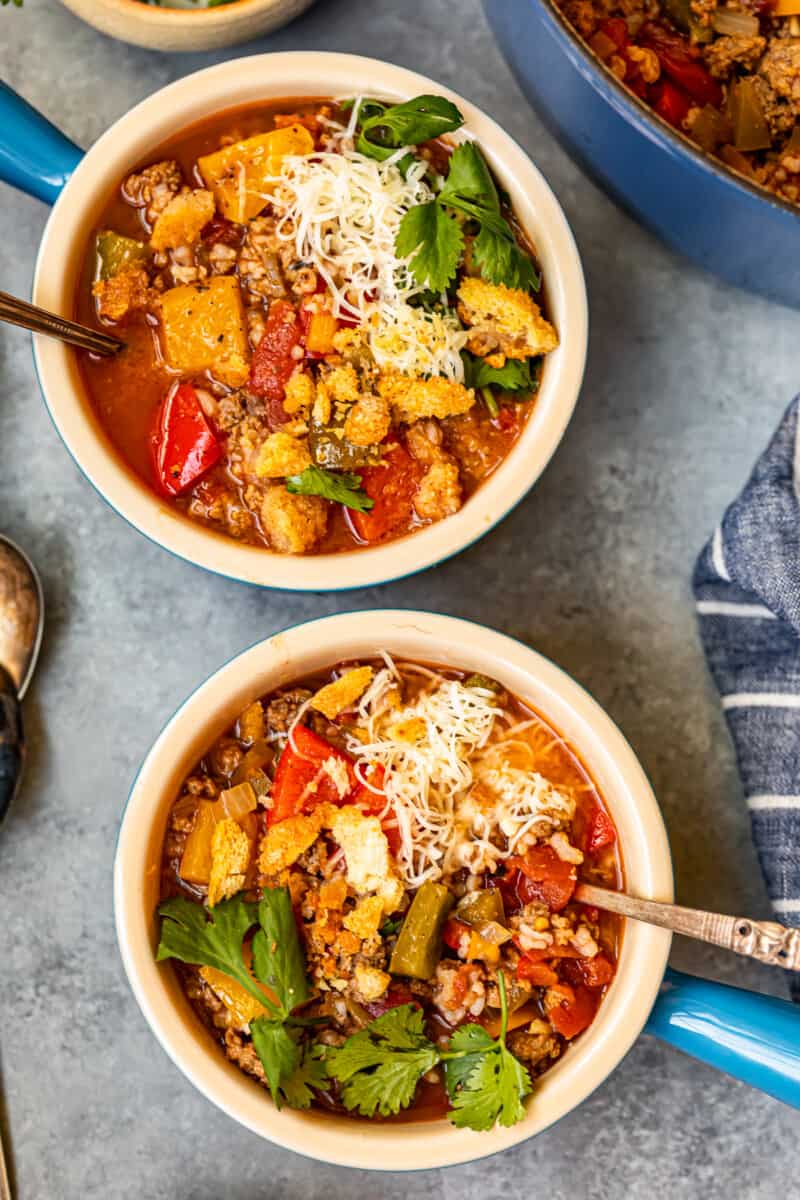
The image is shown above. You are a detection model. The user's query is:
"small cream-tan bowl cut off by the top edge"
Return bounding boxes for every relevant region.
[61,0,313,50]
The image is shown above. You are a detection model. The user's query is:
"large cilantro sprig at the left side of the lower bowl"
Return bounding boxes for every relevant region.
[156,888,323,1108]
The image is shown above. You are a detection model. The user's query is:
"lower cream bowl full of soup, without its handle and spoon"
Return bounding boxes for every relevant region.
[114,611,672,1170]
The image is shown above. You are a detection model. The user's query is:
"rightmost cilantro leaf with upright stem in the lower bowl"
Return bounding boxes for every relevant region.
[445,971,531,1130]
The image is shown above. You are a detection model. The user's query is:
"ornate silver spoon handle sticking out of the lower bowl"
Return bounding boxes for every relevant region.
[575,883,800,971]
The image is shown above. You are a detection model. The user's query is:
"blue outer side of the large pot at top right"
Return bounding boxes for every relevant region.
[483,0,800,307]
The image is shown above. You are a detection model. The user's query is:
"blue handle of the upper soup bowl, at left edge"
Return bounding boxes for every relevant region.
[0,80,83,204]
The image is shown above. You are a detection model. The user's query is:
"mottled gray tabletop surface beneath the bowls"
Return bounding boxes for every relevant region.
[0,0,800,1200]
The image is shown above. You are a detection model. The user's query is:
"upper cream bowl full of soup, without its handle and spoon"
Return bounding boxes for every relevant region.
[0,54,587,590]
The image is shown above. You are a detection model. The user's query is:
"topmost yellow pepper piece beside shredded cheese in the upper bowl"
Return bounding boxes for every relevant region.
[197,125,314,224]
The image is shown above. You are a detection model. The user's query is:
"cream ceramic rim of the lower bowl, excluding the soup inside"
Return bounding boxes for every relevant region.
[114,610,673,1171]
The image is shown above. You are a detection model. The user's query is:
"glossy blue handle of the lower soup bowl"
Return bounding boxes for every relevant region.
[645,968,800,1109]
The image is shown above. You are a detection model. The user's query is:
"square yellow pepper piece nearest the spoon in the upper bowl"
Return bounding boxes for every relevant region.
[160,275,249,388]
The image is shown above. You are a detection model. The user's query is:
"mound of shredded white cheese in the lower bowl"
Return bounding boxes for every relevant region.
[348,655,575,888]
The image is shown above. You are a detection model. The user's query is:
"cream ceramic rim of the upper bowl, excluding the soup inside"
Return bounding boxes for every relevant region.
[34,53,587,592]
